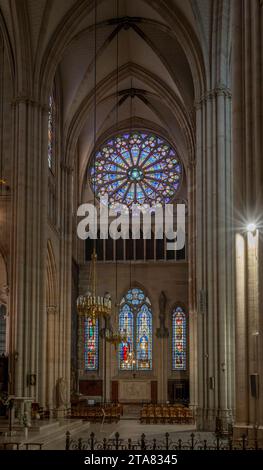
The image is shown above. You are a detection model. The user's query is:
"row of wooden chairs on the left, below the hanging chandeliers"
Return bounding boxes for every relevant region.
[70,405,121,423]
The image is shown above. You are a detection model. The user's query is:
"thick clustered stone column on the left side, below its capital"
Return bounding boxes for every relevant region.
[10,96,48,405]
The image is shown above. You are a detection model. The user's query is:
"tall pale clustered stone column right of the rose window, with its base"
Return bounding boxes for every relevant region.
[196,84,234,431]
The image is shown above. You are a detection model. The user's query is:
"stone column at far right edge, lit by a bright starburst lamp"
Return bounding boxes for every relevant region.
[232,0,263,443]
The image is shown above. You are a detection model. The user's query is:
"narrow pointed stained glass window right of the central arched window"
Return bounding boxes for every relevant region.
[172,307,187,370]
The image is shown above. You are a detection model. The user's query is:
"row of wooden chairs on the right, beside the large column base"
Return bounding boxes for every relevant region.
[140,405,194,424]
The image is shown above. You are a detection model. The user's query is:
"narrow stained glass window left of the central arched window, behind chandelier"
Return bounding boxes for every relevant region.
[84,318,99,370]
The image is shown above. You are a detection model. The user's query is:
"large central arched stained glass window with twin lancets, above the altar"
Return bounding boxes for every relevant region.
[119,288,152,370]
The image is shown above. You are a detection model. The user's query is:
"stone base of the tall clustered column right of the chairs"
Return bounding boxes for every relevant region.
[196,408,233,434]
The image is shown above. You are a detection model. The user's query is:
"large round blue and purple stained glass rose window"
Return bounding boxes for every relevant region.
[90,131,182,206]
